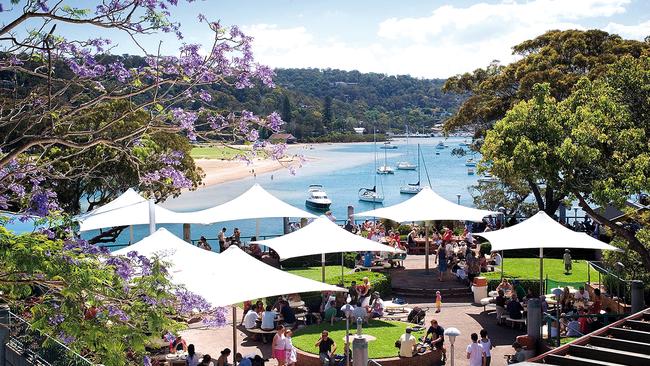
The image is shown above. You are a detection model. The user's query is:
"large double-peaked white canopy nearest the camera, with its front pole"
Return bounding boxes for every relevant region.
[113,228,347,362]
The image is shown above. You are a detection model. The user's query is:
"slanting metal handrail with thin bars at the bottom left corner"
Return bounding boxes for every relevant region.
[0,311,94,366]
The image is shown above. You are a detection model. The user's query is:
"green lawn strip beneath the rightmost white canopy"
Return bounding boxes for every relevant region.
[484,256,587,282]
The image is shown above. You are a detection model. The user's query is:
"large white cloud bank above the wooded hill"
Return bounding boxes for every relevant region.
[245,0,650,78]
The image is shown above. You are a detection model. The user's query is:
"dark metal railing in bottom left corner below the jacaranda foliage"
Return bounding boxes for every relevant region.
[0,309,93,366]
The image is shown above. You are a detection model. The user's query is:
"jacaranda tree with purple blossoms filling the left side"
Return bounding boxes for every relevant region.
[0,0,284,365]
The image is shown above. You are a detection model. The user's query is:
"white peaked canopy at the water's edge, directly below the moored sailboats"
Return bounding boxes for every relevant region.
[357,187,499,272]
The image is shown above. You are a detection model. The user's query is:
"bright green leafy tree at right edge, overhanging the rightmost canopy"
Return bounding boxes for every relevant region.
[481,57,650,270]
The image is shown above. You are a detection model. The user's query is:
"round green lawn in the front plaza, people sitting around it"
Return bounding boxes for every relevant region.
[292,320,424,358]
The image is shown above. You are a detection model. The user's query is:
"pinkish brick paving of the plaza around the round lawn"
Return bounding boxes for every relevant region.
[182,256,525,366]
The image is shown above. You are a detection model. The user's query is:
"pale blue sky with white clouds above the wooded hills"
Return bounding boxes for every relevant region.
[0,0,650,78]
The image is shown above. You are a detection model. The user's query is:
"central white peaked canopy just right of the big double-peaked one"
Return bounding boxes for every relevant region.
[253,216,403,281]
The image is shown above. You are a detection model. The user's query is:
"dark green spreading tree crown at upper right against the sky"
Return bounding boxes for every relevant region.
[443,30,650,135]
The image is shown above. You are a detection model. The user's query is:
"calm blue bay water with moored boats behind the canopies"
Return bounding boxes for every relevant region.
[77,138,477,249]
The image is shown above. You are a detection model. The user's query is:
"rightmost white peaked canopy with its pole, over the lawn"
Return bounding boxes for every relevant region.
[474,211,620,290]
